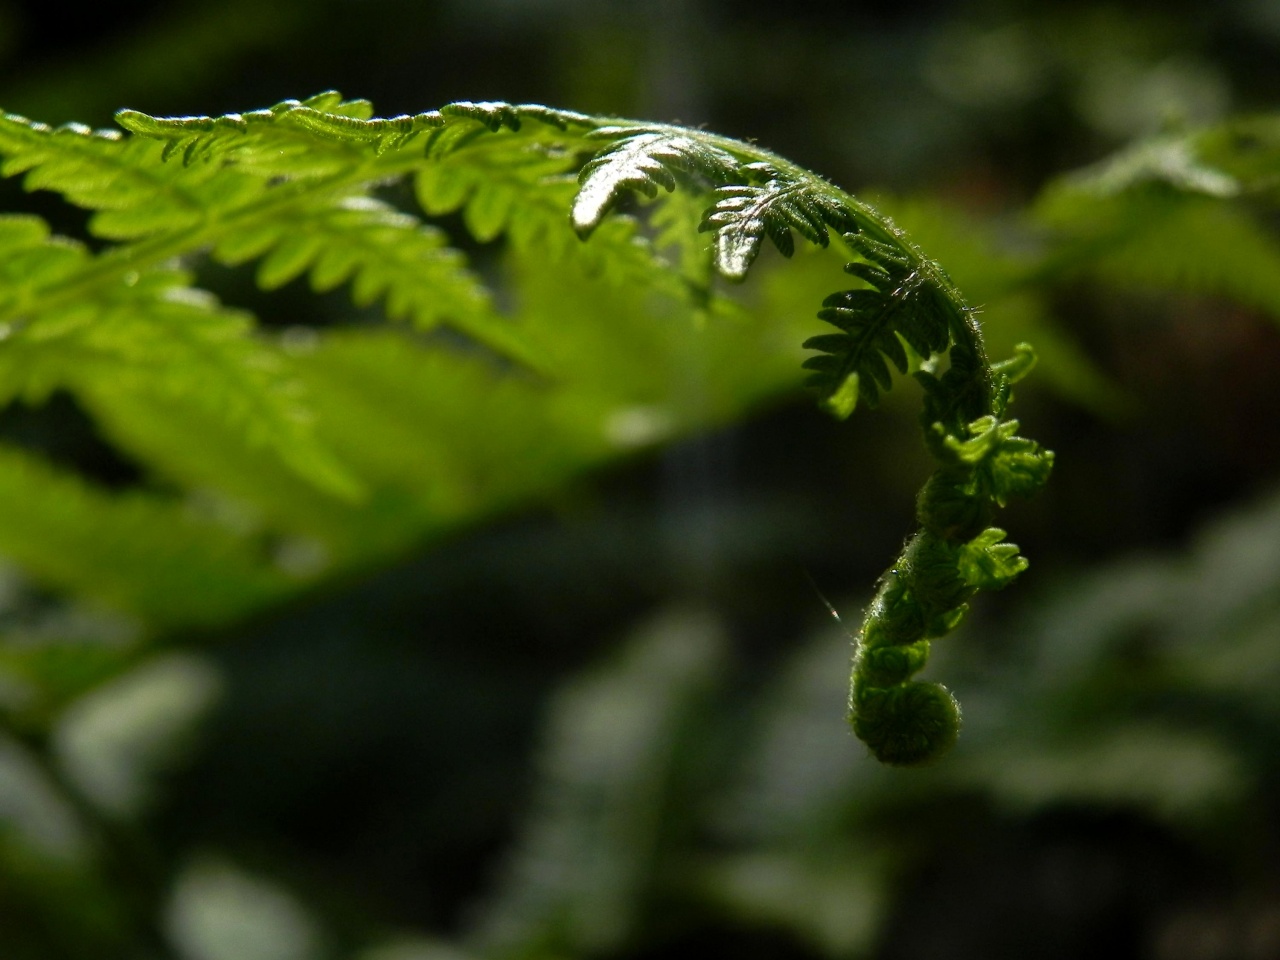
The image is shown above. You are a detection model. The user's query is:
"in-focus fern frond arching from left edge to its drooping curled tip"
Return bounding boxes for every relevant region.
[0,92,1052,764]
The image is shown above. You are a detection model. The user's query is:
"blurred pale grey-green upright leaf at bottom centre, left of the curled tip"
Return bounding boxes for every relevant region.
[468,611,727,960]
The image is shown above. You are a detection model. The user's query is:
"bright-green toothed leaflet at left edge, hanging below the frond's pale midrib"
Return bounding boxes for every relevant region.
[0,216,357,497]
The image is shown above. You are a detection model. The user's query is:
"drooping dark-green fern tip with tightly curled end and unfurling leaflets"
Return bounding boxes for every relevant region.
[575,122,1053,764]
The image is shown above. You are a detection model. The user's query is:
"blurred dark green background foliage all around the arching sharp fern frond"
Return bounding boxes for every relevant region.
[0,0,1280,960]
